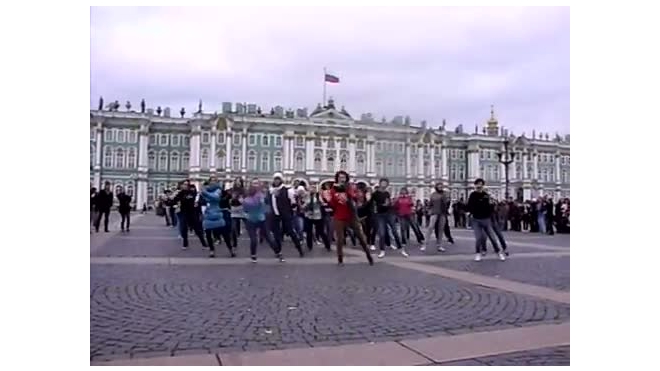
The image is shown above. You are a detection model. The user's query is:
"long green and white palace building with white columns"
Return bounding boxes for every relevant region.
[89,99,570,207]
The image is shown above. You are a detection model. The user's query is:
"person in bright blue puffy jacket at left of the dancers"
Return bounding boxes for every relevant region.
[202,176,236,258]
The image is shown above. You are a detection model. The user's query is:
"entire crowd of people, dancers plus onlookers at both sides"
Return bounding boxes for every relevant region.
[90,171,570,264]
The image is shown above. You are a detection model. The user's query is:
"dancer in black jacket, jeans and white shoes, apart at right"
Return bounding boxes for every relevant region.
[467,178,506,261]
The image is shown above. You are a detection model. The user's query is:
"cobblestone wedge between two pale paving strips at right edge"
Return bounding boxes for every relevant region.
[425,256,571,291]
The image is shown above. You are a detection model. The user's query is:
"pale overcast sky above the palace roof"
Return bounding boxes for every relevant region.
[90,7,570,137]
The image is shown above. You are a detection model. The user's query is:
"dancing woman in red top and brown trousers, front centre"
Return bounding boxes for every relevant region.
[326,170,374,265]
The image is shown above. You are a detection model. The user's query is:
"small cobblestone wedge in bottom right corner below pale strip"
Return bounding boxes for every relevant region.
[436,346,571,366]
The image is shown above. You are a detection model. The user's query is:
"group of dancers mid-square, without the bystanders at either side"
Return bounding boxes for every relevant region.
[150,171,508,265]
